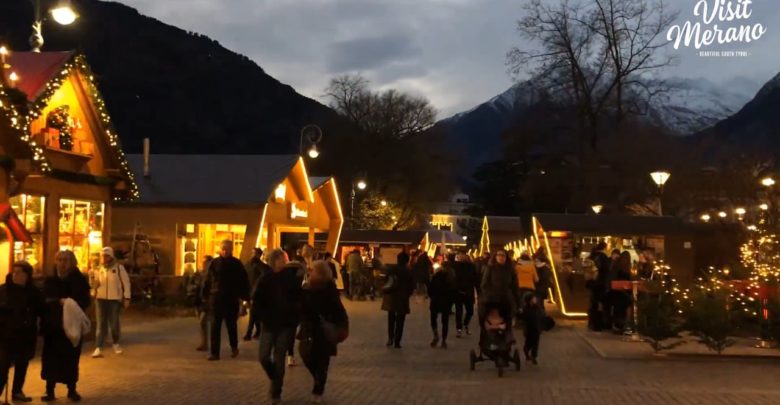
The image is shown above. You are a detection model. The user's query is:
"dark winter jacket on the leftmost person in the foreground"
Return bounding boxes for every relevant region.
[0,274,44,360]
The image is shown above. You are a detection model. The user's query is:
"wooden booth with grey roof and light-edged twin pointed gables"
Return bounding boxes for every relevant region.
[111,154,343,276]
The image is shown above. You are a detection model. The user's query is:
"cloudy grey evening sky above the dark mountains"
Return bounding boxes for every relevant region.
[119,0,780,117]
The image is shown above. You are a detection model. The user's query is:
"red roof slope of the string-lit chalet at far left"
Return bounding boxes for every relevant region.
[7,51,75,102]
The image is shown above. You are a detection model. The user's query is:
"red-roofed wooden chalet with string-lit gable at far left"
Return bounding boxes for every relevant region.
[0,52,138,277]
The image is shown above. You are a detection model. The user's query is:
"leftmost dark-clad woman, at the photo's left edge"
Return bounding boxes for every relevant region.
[0,262,43,402]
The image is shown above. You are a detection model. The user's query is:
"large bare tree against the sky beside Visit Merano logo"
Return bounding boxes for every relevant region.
[507,0,674,149]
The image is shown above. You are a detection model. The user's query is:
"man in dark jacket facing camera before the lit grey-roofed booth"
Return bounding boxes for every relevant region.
[203,240,249,361]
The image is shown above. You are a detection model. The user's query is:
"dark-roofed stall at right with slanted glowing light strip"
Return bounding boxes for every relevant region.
[507,214,695,316]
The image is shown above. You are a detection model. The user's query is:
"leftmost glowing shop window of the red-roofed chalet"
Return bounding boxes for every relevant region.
[10,194,46,274]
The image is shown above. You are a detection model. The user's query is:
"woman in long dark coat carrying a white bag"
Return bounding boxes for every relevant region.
[41,251,90,402]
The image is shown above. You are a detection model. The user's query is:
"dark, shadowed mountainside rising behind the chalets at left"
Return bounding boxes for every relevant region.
[0,0,337,153]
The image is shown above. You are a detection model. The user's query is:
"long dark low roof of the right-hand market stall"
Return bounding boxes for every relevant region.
[534,214,687,236]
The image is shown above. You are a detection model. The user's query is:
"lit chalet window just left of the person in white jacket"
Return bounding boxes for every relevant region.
[59,199,105,271]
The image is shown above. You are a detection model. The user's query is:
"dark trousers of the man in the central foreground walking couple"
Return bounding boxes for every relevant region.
[260,325,295,398]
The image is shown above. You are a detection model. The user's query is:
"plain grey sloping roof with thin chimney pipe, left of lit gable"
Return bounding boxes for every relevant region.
[128,154,298,205]
